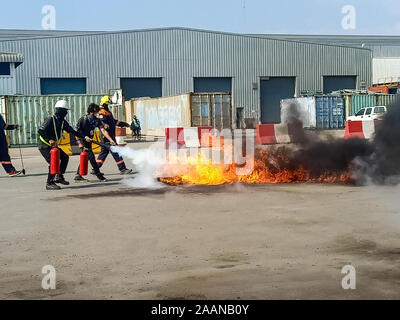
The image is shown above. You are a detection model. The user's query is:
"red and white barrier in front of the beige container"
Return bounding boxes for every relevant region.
[165,126,213,149]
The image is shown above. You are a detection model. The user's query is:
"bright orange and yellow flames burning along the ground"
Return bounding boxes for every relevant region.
[160,149,353,185]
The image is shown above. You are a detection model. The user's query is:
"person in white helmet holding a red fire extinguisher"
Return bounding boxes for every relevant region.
[38,100,85,190]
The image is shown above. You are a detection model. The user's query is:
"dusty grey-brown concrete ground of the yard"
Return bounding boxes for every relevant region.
[0,136,400,299]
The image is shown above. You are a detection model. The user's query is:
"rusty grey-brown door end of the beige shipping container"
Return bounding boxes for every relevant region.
[191,93,232,130]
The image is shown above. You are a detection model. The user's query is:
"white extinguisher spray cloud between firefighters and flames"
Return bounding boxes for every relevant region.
[111,142,165,189]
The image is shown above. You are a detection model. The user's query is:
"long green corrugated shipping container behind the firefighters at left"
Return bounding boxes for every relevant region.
[5,94,106,146]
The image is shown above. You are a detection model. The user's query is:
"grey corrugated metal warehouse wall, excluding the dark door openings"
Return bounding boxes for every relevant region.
[0,28,372,118]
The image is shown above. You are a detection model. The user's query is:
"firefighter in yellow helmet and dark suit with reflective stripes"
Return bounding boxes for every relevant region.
[92,96,132,174]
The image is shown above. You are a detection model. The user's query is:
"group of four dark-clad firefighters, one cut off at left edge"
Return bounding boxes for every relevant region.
[0,96,140,190]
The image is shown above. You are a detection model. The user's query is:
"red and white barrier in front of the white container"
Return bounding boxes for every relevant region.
[256,124,302,145]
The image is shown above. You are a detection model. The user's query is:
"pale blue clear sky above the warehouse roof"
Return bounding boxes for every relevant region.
[0,0,400,35]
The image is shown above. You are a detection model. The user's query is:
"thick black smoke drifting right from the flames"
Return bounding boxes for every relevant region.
[273,100,400,185]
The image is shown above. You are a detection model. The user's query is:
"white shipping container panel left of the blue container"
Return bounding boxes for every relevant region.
[281,97,317,129]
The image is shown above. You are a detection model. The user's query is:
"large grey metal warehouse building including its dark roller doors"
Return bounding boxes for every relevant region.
[0,28,372,123]
